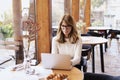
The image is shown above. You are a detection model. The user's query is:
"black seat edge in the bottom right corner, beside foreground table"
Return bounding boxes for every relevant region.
[84,73,120,80]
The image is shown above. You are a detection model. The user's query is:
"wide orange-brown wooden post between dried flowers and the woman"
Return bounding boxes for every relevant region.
[36,0,51,61]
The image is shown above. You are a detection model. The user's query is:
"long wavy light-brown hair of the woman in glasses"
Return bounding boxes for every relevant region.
[57,14,79,44]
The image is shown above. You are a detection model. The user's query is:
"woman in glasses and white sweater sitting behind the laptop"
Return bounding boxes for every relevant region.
[52,14,82,66]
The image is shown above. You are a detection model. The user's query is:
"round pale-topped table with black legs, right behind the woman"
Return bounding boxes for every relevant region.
[81,36,108,73]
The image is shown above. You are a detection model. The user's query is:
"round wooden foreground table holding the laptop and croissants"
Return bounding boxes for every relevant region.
[0,65,84,80]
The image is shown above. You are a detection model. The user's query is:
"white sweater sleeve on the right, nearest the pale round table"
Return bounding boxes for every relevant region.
[71,38,82,66]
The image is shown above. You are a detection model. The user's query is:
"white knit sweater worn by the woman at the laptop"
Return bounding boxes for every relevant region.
[51,37,82,66]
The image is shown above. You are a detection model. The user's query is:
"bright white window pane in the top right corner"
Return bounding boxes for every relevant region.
[104,0,120,30]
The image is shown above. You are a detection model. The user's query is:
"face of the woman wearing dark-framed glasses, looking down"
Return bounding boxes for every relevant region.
[61,21,72,38]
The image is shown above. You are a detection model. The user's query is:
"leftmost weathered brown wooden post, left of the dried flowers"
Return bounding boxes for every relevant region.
[12,0,24,64]
